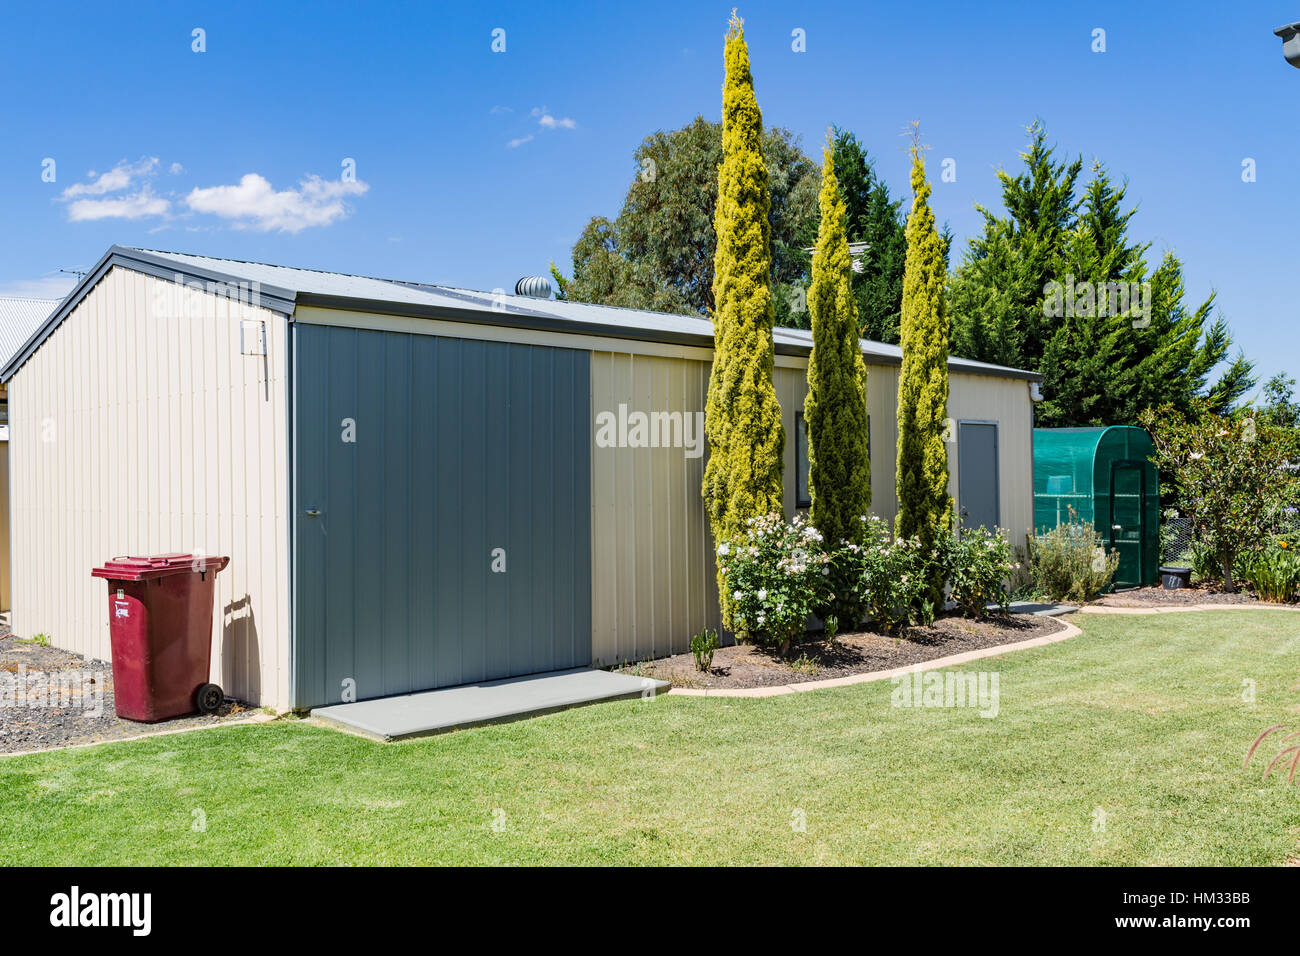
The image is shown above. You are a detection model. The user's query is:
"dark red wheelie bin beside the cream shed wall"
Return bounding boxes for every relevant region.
[91,554,230,723]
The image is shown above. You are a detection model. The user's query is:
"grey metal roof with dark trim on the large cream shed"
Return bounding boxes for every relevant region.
[0,246,1041,381]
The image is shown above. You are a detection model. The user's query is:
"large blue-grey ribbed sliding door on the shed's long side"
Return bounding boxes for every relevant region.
[293,323,592,708]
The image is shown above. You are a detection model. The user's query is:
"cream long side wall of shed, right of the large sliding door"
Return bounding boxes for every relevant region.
[592,350,1034,666]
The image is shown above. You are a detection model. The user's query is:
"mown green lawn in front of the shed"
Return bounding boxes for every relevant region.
[0,611,1300,865]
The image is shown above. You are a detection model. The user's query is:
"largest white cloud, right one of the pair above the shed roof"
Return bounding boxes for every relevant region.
[185,173,371,233]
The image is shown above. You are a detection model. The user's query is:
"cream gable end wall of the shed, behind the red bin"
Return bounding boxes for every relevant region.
[9,267,289,708]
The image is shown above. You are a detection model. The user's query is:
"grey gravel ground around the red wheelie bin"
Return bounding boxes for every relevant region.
[0,628,255,753]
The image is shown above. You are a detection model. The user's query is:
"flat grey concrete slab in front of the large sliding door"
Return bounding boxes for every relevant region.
[312,667,670,740]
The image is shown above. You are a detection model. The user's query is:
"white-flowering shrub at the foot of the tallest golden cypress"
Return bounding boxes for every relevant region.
[718,514,831,648]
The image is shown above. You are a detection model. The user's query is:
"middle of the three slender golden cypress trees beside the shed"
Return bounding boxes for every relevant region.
[803,138,871,548]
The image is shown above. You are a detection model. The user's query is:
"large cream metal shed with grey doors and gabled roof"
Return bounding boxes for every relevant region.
[0,246,1037,709]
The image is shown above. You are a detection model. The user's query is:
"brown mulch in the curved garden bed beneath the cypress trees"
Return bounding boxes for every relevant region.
[623,614,1065,688]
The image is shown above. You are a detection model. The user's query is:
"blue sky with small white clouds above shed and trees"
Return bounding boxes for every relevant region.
[0,0,1300,395]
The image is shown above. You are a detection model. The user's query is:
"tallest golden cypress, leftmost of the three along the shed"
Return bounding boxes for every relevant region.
[702,12,785,627]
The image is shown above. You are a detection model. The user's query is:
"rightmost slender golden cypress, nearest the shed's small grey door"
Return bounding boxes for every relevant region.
[894,142,953,607]
